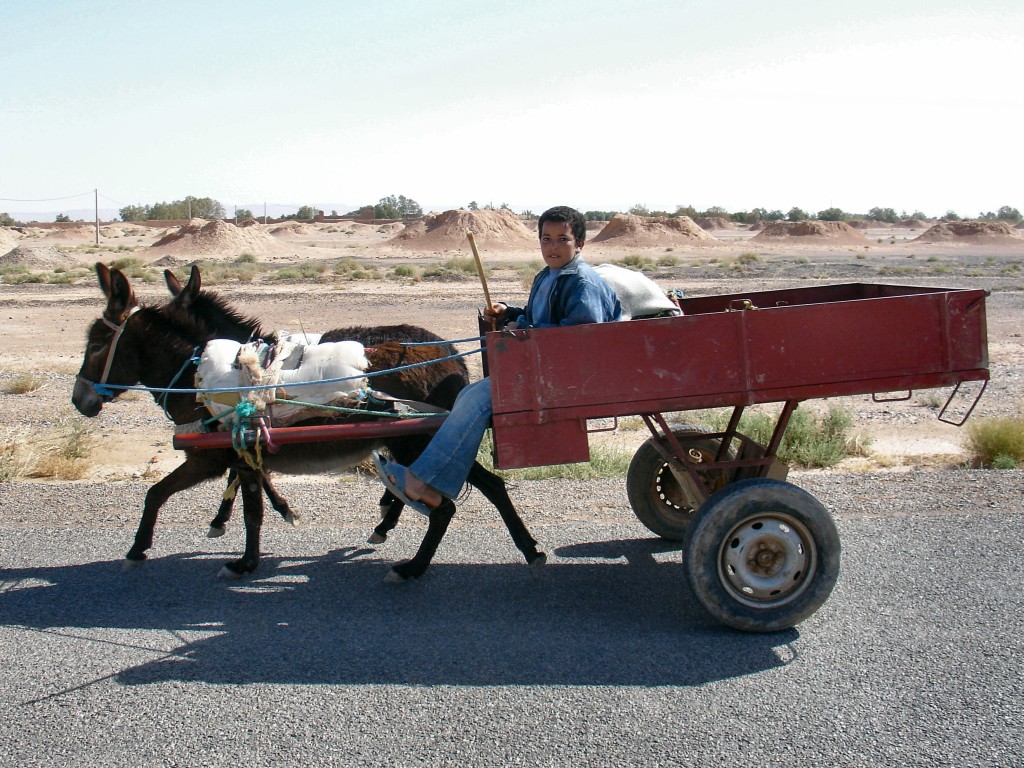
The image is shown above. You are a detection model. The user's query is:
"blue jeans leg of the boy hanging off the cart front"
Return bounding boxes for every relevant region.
[409,379,492,499]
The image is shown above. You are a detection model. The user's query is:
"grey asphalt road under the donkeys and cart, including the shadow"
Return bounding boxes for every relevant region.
[0,473,1024,768]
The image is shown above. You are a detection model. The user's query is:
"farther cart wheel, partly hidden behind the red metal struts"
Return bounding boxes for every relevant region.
[626,426,735,542]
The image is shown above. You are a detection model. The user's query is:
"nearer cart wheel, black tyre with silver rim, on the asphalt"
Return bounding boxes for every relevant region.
[683,477,840,632]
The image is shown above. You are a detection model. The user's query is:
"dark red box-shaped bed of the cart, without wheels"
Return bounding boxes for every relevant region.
[486,283,988,469]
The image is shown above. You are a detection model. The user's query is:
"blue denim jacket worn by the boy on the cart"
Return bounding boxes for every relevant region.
[506,255,623,328]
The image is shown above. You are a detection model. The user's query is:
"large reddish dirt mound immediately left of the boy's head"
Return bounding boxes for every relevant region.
[384,208,537,251]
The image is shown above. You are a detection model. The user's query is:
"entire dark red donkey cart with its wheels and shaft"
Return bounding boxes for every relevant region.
[175,284,988,632]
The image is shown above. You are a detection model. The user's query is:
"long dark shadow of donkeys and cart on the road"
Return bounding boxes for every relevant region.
[0,539,798,686]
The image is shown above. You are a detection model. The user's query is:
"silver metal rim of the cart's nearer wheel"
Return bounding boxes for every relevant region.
[719,513,817,608]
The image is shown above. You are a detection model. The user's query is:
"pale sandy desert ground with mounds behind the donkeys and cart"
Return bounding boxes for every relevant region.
[0,212,1024,479]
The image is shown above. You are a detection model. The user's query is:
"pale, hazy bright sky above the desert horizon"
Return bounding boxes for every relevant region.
[0,0,1024,218]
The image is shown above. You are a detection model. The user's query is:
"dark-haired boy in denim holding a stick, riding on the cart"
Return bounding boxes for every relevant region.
[374,206,622,515]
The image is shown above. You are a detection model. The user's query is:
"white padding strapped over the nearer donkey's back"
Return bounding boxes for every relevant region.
[196,342,370,426]
